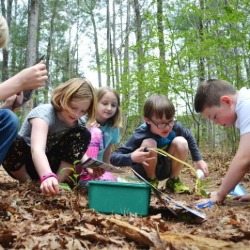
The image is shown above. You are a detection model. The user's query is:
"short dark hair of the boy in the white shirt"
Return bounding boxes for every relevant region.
[194,79,237,113]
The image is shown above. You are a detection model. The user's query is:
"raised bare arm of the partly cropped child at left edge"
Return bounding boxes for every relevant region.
[0,62,48,101]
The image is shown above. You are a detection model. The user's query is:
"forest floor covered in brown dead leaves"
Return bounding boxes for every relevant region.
[0,153,250,250]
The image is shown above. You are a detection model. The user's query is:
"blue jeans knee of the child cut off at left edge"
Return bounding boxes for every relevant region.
[0,109,19,164]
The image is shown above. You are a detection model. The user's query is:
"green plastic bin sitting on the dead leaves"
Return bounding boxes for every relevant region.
[88,181,151,216]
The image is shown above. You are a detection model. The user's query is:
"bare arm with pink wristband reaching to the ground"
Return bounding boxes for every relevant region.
[30,118,59,195]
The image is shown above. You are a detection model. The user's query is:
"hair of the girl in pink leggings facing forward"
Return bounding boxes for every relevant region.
[96,86,122,128]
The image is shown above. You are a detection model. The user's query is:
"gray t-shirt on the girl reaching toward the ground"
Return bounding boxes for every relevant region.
[19,104,81,151]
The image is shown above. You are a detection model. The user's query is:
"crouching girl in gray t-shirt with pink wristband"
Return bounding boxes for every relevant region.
[2,78,103,195]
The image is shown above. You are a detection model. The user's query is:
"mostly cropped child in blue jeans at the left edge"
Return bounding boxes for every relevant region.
[0,15,48,165]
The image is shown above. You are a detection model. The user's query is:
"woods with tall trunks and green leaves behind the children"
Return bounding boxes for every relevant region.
[0,0,250,153]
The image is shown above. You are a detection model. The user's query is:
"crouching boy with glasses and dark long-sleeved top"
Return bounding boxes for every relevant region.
[110,94,208,193]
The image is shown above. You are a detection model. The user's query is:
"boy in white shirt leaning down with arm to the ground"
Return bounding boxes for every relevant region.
[194,79,250,203]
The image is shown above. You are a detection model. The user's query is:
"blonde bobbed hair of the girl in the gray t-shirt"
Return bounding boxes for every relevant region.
[51,78,97,122]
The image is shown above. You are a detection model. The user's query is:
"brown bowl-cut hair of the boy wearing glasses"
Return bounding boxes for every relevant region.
[144,94,175,119]
